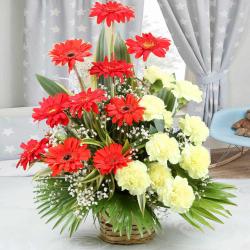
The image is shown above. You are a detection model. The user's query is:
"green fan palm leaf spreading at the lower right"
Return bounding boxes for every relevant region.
[181,181,236,231]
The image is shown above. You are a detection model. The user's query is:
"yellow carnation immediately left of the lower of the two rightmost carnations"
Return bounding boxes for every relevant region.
[145,132,180,164]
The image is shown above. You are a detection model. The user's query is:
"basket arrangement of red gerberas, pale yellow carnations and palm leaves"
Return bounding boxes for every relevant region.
[17,1,234,243]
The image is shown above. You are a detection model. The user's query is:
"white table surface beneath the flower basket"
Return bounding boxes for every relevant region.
[0,177,250,250]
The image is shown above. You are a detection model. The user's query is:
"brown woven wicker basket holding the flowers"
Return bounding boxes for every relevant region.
[99,219,155,245]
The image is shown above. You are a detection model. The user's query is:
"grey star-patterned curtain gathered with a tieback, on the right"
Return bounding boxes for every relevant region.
[158,0,250,125]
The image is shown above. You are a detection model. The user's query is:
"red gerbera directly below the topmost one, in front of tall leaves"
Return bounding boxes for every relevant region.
[90,57,134,82]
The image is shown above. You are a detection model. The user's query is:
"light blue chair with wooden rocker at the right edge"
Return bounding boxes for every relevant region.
[210,107,250,167]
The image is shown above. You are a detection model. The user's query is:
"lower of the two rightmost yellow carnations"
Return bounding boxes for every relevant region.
[180,145,210,179]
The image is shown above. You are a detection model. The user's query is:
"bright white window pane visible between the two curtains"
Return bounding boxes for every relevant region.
[142,0,186,79]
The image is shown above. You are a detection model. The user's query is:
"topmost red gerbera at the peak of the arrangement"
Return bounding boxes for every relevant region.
[89,1,135,27]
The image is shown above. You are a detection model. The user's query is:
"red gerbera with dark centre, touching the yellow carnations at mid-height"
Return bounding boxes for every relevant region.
[106,94,144,126]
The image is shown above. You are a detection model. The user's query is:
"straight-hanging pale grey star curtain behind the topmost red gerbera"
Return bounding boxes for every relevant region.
[23,0,144,106]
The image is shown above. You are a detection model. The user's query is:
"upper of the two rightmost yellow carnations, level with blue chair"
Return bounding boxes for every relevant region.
[179,114,209,145]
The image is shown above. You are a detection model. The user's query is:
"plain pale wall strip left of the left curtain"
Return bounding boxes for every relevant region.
[0,0,25,108]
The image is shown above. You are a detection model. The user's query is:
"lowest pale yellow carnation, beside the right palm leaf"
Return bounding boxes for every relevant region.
[159,176,195,213]
